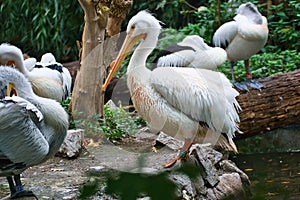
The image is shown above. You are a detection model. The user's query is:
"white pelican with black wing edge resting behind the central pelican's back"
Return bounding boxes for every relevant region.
[153,35,227,70]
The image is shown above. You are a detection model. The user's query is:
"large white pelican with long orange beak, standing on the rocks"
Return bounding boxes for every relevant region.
[102,11,239,167]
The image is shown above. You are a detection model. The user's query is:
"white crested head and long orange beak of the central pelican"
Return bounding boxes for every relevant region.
[102,10,161,91]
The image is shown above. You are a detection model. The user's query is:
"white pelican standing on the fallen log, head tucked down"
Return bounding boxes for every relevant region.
[213,2,269,90]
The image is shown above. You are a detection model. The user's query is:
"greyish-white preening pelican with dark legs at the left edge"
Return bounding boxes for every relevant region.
[0,66,68,198]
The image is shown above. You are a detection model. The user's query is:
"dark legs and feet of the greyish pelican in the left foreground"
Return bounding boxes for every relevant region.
[7,175,38,199]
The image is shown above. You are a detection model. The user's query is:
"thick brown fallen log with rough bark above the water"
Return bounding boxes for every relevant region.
[237,70,300,138]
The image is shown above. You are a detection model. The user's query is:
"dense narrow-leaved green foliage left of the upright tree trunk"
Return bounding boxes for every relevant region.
[0,0,83,61]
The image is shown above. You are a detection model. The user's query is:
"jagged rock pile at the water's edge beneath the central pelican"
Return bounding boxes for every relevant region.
[164,144,250,200]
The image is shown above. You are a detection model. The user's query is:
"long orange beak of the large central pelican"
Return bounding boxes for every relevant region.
[102,29,146,92]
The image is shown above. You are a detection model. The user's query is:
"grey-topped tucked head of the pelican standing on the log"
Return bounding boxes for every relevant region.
[236,2,262,24]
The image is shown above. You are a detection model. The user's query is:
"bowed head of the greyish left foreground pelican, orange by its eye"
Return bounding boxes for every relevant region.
[0,66,33,98]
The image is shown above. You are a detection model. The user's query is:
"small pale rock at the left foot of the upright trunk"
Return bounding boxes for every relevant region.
[56,129,84,158]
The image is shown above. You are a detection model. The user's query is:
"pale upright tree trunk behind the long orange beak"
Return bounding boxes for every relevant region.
[71,0,132,119]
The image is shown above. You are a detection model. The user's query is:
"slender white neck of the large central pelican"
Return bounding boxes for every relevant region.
[127,29,159,73]
